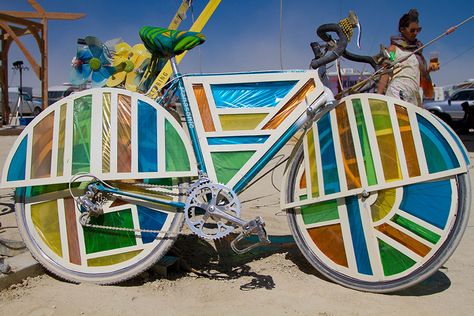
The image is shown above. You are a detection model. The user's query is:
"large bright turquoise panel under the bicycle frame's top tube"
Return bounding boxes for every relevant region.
[211,81,297,109]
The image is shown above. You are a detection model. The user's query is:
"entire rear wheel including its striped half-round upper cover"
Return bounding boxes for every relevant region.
[1,88,197,283]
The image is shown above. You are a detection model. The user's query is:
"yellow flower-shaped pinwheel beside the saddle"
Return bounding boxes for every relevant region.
[107,42,151,91]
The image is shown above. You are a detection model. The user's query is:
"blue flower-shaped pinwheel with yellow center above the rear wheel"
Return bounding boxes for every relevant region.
[69,36,116,87]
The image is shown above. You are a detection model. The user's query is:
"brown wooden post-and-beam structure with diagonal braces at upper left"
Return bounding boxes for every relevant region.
[0,0,85,123]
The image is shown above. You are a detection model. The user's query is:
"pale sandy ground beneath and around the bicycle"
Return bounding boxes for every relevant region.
[0,136,474,315]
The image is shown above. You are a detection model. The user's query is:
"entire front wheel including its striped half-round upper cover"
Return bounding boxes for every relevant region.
[282,94,470,292]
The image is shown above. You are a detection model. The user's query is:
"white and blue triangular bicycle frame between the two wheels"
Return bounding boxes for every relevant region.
[172,60,333,193]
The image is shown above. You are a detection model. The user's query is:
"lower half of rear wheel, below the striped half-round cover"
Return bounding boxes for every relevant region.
[16,181,183,284]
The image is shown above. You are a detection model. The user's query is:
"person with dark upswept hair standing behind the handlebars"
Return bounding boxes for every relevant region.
[377,9,439,106]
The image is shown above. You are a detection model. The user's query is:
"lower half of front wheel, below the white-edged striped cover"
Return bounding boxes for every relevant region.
[287,150,471,292]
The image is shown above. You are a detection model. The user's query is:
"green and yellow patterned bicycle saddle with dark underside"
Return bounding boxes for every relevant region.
[139,26,206,58]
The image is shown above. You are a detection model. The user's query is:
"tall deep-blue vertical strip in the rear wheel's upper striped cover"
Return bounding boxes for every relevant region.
[138,100,158,172]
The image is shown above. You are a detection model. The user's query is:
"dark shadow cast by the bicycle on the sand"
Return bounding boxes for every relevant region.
[121,235,451,296]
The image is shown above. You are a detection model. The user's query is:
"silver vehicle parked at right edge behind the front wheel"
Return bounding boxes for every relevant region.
[424,88,474,125]
